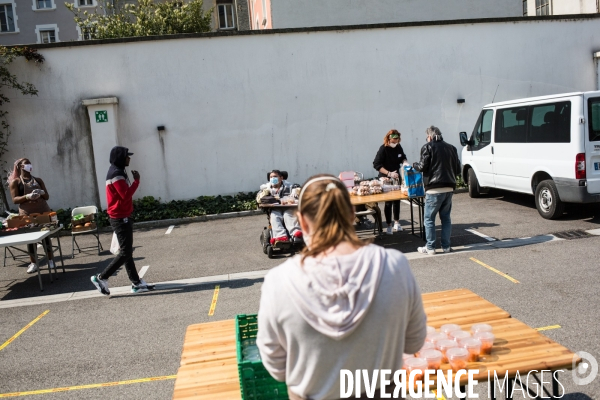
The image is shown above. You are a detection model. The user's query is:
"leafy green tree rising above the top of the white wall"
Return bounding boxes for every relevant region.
[65,0,214,40]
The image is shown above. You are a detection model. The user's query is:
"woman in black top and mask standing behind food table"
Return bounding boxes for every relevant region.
[373,129,406,235]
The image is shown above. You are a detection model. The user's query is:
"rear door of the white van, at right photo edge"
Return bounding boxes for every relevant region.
[584,93,600,194]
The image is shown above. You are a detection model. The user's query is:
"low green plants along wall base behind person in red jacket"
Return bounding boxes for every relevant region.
[56,192,257,229]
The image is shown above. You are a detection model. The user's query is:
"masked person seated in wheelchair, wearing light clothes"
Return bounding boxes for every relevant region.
[260,169,302,244]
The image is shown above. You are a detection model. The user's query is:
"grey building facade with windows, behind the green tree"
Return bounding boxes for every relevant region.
[0,0,250,45]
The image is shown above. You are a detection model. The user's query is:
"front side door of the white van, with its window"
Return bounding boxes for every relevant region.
[463,110,494,187]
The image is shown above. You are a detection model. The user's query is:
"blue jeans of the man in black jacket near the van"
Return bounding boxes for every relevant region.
[425,192,453,250]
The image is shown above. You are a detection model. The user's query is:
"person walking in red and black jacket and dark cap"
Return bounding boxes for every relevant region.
[90,146,154,296]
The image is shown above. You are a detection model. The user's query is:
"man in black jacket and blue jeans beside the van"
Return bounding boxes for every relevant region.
[413,126,460,255]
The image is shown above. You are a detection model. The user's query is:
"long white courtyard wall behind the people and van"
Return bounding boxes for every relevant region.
[7,18,600,208]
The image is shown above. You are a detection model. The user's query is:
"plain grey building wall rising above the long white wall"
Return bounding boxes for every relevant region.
[271,0,524,29]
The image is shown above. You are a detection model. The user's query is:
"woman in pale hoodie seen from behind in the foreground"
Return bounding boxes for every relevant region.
[256,175,427,400]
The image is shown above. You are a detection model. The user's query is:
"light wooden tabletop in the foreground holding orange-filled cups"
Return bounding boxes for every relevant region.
[173,289,573,400]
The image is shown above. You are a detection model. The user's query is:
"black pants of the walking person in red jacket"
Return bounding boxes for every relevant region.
[100,218,140,284]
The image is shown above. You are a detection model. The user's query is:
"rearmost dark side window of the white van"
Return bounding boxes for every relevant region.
[527,101,571,143]
